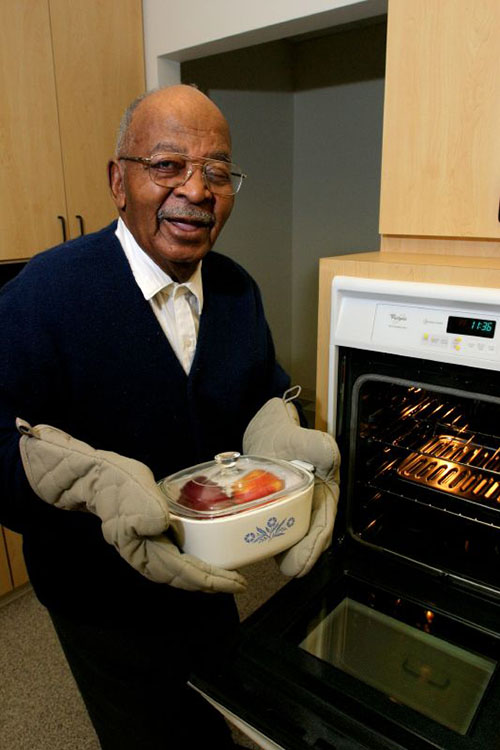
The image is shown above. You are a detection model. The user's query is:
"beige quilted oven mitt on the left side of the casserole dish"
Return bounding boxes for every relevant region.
[16,419,246,593]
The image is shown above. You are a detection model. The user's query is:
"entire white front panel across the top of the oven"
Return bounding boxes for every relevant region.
[330,276,500,370]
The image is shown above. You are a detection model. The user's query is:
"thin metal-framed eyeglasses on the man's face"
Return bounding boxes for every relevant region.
[118,153,246,196]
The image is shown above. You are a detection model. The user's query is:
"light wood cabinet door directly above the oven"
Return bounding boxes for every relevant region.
[380,0,500,239]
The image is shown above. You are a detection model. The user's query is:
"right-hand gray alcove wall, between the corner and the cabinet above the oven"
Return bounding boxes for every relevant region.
[292,23,385,389]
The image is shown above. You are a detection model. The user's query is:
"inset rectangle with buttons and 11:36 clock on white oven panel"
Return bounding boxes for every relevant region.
[372,304,500,359]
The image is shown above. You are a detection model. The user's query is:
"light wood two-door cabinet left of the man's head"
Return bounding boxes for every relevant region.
[0,0,145,260]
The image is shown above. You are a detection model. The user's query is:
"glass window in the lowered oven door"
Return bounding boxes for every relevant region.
[300,597,496,734]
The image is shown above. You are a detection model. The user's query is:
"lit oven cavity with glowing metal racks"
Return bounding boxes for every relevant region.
[344,375,500,590]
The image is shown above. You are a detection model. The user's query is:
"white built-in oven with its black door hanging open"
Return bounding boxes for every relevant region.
[191,276,500,750]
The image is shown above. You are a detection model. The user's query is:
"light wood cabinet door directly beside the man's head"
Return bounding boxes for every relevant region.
[49,0,145,237]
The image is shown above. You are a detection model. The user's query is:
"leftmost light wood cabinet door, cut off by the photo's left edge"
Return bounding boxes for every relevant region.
[0,0,66,260]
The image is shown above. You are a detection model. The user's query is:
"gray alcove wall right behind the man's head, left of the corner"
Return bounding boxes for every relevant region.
[182,42,293,372]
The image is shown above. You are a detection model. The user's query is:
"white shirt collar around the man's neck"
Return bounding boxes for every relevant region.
[115,217,203,315]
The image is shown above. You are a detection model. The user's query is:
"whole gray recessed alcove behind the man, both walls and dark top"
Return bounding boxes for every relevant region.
[182,20,385,393]
